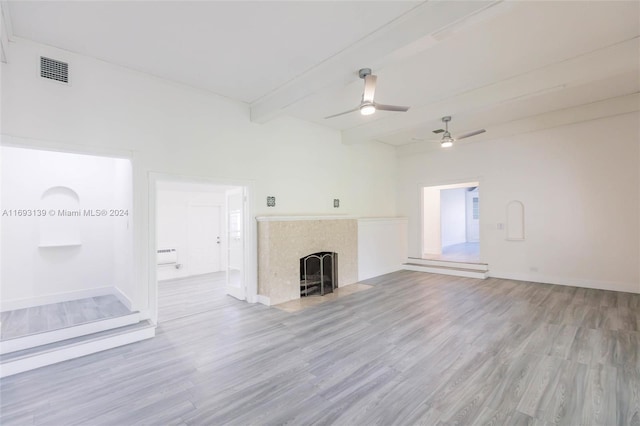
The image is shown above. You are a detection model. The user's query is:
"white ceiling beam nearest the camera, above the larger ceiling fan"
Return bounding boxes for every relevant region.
[251,0,502,123]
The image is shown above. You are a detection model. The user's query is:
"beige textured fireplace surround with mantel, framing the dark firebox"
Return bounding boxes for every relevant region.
[256,215,358,305]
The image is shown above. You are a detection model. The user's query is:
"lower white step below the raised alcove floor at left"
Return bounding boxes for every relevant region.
[0,320,156,377]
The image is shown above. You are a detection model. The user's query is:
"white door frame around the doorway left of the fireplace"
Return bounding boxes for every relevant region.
[147,172,258,324]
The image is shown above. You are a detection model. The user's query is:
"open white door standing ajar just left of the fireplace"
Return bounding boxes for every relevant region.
[226,188,246,300]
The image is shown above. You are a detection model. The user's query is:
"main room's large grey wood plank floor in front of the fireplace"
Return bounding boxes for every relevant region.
[0,271,640,425]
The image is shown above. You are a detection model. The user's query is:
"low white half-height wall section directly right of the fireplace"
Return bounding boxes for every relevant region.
[358,218,407,281]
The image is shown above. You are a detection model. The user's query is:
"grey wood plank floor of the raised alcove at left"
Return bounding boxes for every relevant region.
[0,295,131,340]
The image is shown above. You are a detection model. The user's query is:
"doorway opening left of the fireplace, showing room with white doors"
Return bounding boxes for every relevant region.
[155,180,248,322]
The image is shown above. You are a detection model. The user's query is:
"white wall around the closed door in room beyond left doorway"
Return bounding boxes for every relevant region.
[156,188,226,280]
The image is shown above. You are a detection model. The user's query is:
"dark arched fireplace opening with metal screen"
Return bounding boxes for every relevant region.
[300,251,338,297]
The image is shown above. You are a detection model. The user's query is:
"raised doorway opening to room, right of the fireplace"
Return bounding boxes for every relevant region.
[422,182,481,263]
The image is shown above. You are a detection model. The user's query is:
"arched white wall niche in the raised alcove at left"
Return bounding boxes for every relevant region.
[38,186,82,248]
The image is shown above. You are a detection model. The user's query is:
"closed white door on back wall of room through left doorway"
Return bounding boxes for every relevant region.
[187,205,221,275]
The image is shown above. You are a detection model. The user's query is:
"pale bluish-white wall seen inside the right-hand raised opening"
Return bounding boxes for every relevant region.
[440,188,467,247]
